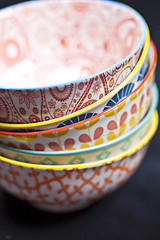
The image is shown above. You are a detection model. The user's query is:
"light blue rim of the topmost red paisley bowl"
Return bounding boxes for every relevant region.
[0,0,147,90]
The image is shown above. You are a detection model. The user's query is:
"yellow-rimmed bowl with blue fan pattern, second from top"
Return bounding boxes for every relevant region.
[0,31,151,132]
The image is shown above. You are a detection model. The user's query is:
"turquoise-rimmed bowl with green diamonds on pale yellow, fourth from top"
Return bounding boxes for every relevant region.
[0,85,159,165]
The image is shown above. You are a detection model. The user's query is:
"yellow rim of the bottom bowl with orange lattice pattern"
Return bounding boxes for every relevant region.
[0,111,159,170]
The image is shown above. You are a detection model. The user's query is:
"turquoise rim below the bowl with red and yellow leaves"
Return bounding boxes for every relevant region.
[0,84,159,156]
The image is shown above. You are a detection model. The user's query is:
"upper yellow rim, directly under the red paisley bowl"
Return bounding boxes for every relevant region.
[0,23,150,128]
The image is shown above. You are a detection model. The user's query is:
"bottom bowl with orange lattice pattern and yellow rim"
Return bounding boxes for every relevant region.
[0,110,158,213]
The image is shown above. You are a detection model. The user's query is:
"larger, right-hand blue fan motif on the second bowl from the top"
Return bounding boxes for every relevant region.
[103,83,134,111]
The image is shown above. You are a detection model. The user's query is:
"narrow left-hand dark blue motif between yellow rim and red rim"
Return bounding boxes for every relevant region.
[58,113,97,128]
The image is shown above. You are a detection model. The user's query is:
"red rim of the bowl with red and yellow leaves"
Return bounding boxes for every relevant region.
[0,37,157,136]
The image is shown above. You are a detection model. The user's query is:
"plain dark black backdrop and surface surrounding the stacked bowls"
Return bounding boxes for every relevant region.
[0,0,160,240]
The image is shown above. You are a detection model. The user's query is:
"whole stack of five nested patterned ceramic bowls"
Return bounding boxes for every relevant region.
[0,1,158,212]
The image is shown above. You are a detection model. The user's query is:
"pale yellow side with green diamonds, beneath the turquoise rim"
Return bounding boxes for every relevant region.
[0,111,155,165]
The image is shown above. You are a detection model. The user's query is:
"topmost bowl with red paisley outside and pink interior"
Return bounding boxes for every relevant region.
[0,1,147,124]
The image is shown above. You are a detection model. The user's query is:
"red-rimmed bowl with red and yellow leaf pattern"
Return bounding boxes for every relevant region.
[0,40,157,151]
